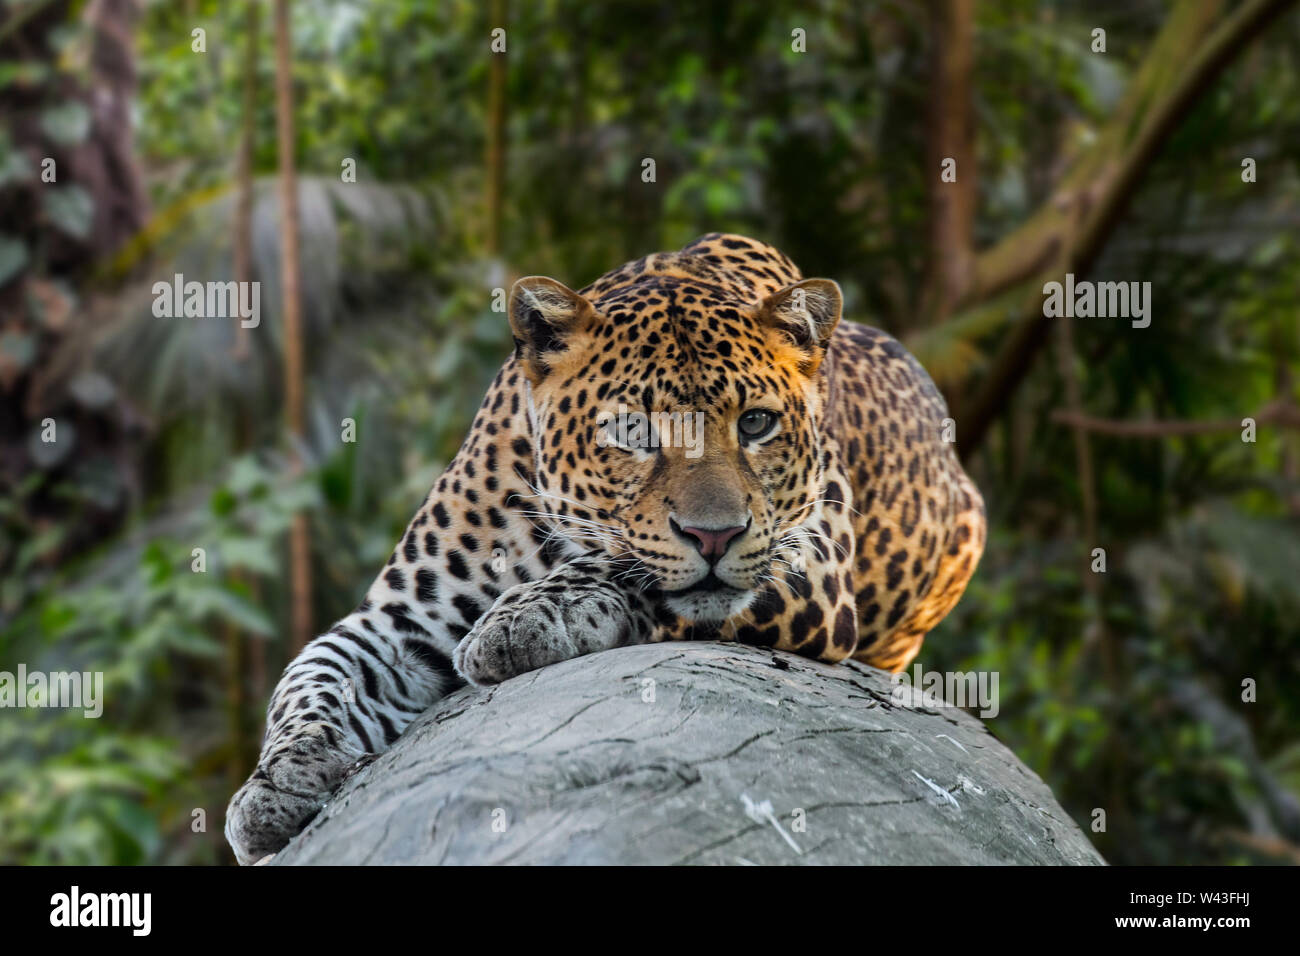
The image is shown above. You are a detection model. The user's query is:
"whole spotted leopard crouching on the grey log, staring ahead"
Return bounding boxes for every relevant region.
[225,233,985,864]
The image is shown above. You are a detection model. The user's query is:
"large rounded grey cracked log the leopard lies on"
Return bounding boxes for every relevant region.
[272,644,1102,864]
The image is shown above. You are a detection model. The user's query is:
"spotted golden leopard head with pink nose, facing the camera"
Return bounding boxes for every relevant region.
[510,243,841,622]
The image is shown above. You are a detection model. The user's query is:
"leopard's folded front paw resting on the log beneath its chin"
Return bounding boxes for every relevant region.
[452,557,655,685]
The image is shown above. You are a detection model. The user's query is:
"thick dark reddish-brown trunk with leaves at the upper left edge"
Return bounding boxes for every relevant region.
[0,0,150,561]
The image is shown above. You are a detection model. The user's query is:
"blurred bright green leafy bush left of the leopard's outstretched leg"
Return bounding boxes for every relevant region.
[0,458,319,864]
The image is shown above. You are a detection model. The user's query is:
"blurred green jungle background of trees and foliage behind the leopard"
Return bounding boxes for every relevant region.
[0,0,1300,864]
